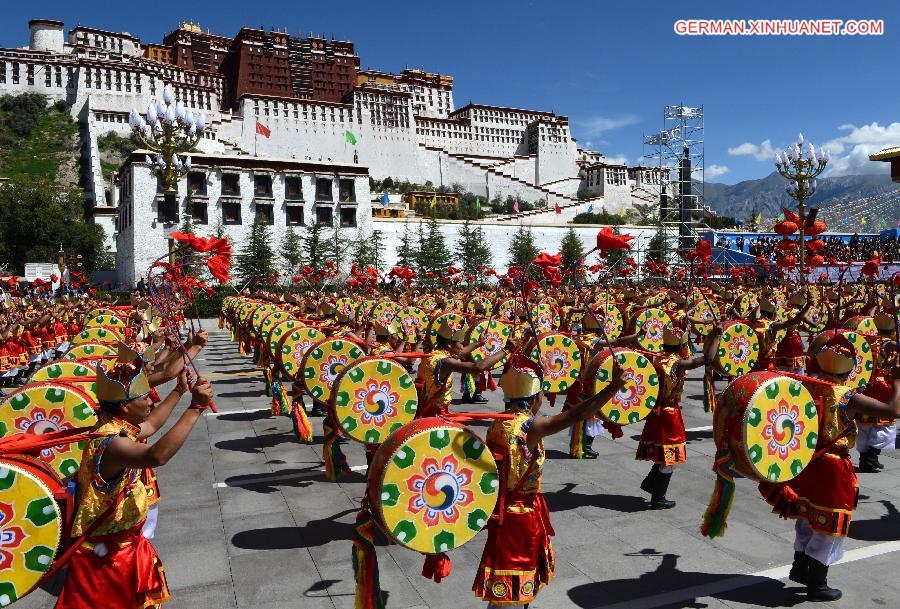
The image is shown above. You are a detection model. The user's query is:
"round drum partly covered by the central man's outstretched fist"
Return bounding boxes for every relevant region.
[588,349,659,425]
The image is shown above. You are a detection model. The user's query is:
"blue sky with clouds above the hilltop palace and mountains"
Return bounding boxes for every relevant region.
[0,0,900,183]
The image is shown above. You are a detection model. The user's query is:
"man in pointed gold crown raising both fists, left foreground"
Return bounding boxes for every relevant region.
[56,346,212,609]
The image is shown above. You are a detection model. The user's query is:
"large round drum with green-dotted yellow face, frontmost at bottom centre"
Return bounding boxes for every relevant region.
[368,418,500,554]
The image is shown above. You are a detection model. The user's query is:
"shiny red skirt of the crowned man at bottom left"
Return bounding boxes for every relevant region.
[56,522,169,609]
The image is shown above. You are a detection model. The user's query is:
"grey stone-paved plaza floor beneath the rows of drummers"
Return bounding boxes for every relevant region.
[16,321,900,609]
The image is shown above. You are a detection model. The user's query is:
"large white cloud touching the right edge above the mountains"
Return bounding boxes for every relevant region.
[822,122,900,176]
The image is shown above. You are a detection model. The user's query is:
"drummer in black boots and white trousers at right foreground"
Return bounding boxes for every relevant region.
[759,334,900,601]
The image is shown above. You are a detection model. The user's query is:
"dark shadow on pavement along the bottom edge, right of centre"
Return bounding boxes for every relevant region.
[568,548,806,609]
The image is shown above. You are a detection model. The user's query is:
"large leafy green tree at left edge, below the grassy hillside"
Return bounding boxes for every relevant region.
[0,176,104,274]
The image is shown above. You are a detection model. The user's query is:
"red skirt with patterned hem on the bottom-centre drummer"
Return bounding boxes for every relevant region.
[472,493,556,605]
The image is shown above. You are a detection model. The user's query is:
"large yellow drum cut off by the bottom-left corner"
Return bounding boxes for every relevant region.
[0,458,65,607]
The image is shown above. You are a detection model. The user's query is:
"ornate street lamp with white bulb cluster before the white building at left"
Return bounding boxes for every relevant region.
[128,85,206,226]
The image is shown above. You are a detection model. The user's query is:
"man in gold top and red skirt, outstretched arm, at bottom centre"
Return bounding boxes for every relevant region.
[472,357,625,607]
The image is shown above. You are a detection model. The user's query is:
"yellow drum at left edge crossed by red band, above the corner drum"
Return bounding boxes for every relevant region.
[0,383,97,478]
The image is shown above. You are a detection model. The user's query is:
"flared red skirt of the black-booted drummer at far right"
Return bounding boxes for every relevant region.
[759,453,859,537]
